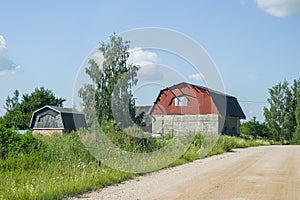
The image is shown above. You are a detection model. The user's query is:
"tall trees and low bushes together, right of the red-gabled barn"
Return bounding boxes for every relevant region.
[241,79,300,143]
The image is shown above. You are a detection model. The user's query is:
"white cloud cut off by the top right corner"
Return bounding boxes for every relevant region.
[256,0,300,17]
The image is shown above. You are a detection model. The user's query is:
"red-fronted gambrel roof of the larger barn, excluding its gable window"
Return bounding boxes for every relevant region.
[152,82,246,119]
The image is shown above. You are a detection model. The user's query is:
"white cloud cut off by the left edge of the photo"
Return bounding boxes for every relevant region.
[0,35,21,76]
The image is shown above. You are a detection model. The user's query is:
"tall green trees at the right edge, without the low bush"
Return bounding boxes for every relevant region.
[264,79,300,142]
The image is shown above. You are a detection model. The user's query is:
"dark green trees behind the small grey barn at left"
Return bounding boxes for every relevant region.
[3,87,65,129]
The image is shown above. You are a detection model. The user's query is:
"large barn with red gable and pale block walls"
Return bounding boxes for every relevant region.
[151,82,246,135]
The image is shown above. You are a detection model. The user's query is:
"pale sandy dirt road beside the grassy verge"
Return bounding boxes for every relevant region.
[76,146,300,200]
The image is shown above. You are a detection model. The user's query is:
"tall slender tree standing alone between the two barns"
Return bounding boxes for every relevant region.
[79,34,139,127]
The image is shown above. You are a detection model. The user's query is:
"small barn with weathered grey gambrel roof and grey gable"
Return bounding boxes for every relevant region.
[30,105,87,135]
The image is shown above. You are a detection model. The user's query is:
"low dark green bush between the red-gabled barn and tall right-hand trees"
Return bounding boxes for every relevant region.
[241,117,269,139]
